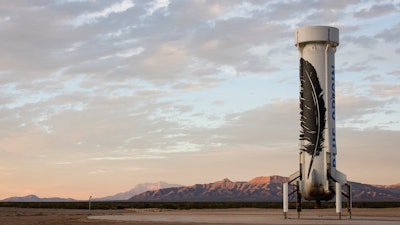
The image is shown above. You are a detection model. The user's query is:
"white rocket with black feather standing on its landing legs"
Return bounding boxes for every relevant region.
[283,26,351,217]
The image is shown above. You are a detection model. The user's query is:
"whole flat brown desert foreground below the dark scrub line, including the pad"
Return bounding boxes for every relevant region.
[0,208,400,225]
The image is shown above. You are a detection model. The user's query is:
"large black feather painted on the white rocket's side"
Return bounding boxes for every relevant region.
[300,58,326,176]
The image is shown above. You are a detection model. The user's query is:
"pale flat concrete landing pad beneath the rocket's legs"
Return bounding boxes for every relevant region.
[88,208,400,225]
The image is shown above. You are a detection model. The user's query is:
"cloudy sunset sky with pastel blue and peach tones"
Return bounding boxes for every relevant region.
[0,0,400,199]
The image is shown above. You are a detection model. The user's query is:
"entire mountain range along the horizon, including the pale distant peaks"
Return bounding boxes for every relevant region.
[3,176,400,202]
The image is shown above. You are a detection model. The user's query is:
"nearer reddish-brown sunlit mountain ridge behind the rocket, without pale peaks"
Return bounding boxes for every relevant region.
[129,175,400,202]
